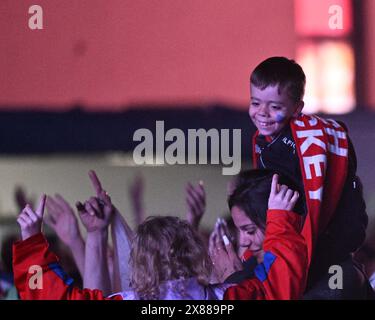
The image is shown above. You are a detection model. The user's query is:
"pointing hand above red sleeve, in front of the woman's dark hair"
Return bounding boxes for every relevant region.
[268,174,299,211]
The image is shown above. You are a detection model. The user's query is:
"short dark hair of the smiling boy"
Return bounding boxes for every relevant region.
[250,57,306,102]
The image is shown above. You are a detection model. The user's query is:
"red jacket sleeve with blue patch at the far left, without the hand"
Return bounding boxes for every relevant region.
[13,233,122,300]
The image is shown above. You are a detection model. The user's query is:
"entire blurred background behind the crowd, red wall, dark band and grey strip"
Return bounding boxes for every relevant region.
[0,0,375,251]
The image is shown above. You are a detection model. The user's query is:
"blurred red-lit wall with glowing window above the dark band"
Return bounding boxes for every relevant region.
[0,0,375,113]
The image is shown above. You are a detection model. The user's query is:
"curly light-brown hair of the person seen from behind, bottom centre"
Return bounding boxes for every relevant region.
[130,216,212,300]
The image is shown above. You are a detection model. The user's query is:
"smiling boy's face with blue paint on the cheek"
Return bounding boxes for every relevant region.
[249,84,303,138]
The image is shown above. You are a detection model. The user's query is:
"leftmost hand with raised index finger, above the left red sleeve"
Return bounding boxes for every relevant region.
[17,194,46,240]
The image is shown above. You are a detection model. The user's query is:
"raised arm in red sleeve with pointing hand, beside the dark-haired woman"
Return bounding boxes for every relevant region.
[262,175,308,300]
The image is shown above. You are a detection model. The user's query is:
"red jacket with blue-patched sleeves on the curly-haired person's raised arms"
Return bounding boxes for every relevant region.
[13,210,307,300]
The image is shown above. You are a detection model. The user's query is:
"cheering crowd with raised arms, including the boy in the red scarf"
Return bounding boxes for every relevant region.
[0,57,375,300]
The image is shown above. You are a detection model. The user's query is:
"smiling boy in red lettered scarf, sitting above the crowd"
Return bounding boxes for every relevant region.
[249,57,368,299]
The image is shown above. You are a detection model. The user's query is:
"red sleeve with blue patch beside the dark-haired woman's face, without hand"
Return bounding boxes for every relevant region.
[224,210,307,300]
